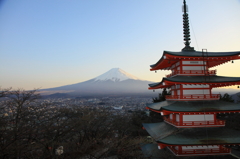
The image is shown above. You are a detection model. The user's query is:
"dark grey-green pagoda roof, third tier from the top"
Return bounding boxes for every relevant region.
[147,100,240,112]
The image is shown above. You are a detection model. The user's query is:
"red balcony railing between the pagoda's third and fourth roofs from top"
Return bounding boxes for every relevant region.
[163,117,225,127]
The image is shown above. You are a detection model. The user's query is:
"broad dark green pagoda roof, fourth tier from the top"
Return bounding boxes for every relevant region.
[143,122,240,145]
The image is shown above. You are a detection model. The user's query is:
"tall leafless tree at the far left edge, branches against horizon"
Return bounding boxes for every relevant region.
[0,89,39,158]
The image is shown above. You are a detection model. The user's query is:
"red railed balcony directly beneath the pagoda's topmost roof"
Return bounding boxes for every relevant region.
[166,70,217,77]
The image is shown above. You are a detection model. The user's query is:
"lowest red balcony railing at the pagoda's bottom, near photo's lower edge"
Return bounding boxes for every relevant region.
[168,146,231,156]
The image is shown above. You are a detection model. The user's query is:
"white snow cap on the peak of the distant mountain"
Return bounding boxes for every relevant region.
[94,68,140,81]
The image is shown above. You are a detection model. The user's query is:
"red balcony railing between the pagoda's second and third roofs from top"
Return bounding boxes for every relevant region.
[165,94,220,101]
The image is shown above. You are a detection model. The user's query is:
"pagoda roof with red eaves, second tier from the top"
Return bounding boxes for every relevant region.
[148,75,240,89]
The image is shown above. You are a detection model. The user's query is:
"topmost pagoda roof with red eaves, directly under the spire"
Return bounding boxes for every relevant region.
[150,51,240,71]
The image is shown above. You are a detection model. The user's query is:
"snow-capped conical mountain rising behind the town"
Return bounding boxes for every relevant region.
[40,68,152,96]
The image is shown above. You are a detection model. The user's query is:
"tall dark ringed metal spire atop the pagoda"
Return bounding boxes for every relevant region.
[182,0,195,51]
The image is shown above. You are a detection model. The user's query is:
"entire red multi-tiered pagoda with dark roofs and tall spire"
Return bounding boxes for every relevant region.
[142,0,240,156]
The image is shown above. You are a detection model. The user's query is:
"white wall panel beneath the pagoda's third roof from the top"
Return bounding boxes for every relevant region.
[183,114,214,122]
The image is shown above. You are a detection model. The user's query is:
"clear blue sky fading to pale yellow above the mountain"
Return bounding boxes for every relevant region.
[0,0,240,90]
